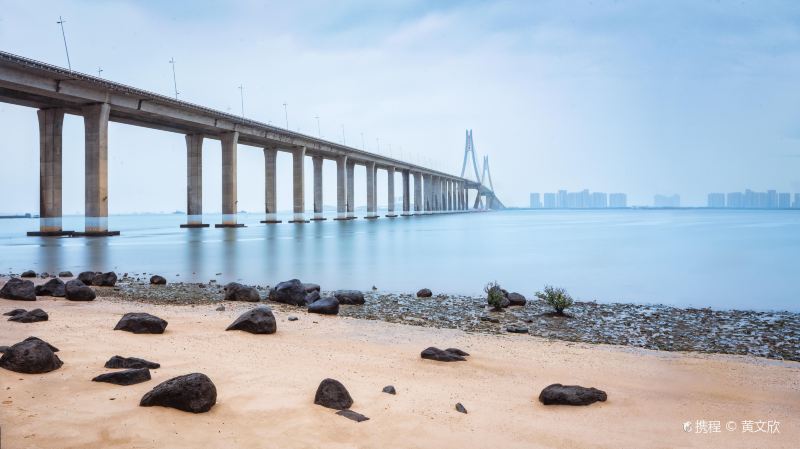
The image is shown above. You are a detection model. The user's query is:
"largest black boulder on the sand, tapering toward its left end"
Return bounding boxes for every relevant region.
[139,373,217,413]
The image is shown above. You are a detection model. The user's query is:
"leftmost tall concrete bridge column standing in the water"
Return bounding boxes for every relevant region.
[28,108,72,236]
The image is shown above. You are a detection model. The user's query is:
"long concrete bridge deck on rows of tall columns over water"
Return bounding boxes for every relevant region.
[0,51,502,236]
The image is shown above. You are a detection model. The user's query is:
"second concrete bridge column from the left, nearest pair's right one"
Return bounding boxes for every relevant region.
[83,103,119,236]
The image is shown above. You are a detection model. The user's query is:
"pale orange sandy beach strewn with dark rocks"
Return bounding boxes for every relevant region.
[0,297,800,448]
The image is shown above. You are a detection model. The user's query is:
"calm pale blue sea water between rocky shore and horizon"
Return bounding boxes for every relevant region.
[0,210,800,311]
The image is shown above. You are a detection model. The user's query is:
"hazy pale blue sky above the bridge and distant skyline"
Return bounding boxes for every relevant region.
[0,0,800,213]
